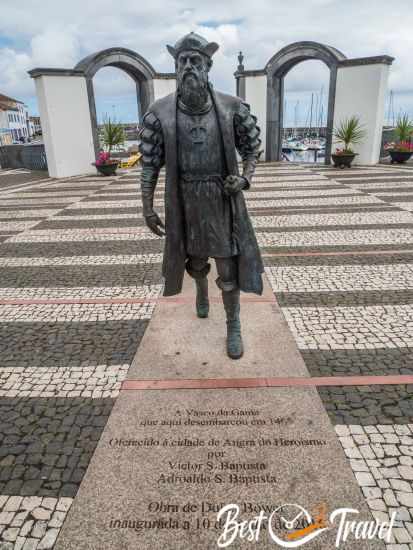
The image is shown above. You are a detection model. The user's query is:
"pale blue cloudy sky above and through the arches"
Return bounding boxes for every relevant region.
[0,0,413,125]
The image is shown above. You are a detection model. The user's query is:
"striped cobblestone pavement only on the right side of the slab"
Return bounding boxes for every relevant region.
[260,166,413,550]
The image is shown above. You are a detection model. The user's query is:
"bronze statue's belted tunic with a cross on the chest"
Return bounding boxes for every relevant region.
[177,103,237,258]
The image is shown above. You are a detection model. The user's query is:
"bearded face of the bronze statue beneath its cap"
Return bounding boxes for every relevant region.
[176,50,211,109]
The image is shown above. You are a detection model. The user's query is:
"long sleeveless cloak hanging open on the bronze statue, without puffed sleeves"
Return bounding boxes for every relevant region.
[149,87,264,296]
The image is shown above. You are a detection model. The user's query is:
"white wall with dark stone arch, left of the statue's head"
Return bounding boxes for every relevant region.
[29,47,176,177]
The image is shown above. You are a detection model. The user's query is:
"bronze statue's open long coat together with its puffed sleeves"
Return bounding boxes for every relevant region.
[139,86,264,296]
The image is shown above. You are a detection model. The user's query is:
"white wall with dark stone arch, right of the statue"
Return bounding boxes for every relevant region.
[235,41,393,164]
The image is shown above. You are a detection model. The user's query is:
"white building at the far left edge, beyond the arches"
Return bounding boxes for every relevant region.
[0,94,32,145]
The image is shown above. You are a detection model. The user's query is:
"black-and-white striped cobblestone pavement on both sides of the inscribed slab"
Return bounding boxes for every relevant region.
[0,164,413,550]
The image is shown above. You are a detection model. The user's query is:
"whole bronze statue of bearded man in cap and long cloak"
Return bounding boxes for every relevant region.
[139,33,263,359]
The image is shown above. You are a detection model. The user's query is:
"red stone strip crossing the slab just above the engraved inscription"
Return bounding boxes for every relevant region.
[121,374,413,390]
